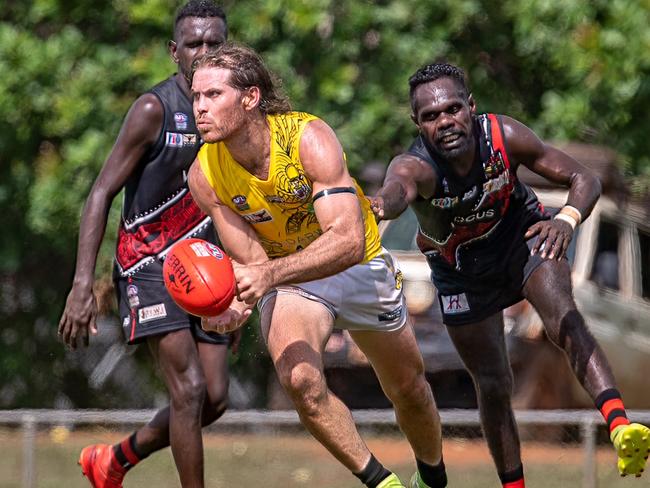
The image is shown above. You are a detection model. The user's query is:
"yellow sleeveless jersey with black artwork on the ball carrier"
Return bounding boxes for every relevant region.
[198,112,381,262]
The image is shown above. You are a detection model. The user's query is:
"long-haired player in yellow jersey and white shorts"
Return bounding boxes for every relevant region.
[189,44,447,488]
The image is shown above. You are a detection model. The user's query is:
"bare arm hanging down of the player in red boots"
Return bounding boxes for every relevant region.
[58,94,163,349]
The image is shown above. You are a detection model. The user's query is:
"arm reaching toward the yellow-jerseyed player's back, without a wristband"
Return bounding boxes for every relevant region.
[370,153,436,220]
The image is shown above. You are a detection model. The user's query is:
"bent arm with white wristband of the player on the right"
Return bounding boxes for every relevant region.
[502,116,601,259]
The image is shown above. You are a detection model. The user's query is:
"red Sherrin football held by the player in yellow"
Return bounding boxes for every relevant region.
[163,239,235,317]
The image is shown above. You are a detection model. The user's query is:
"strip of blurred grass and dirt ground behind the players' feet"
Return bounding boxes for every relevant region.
[0,430,632,488]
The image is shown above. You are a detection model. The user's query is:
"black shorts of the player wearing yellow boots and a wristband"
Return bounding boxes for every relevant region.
[432,237,545,326]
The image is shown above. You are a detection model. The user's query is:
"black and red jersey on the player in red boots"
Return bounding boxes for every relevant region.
[115,76,215,279]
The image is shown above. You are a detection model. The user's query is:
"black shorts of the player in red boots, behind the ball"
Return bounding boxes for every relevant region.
[114,265,230,344]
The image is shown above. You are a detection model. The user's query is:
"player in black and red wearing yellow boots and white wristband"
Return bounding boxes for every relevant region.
[372,64,650,488]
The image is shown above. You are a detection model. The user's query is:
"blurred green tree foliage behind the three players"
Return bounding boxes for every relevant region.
[0,0,650,408]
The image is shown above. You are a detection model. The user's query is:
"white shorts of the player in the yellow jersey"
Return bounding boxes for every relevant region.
[258,248,407,332]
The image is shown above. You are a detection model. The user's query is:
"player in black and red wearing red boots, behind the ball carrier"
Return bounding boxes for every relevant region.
[59,0,229,488]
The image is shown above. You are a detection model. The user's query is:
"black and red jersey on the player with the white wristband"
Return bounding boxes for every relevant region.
[408,114,548,276]
